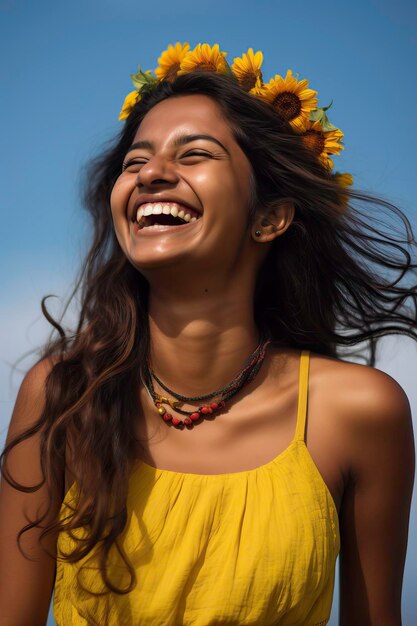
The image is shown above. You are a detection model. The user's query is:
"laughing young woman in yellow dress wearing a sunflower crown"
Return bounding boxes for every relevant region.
[0,44,416,626]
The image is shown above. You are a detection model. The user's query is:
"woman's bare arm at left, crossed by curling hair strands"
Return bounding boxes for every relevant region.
[0,361,60,626]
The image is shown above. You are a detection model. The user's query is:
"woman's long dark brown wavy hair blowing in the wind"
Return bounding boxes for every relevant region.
[1,72,417,593]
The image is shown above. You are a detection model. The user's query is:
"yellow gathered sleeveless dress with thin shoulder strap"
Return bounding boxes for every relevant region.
[54,350,340,626]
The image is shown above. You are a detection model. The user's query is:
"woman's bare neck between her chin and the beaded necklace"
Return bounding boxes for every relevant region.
[149,276,259,396]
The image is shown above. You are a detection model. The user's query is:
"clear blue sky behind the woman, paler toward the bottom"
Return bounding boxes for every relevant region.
[0,0,417,626]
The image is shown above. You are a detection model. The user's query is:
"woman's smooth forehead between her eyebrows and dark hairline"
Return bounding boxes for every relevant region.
[135,94,234,142]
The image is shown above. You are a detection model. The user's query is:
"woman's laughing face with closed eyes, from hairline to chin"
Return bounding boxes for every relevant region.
[111,94,256,275]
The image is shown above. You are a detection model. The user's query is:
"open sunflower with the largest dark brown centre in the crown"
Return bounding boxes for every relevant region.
[262,70,317,130]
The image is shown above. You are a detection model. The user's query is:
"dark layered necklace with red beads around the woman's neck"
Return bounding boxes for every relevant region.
[142,337,270,428]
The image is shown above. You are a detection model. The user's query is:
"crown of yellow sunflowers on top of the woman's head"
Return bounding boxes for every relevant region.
[119,42,353,188]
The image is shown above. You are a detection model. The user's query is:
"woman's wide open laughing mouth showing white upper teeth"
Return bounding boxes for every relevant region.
[136,202,201,230]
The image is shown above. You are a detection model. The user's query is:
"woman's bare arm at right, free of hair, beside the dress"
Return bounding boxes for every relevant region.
[340,366,415,626]
